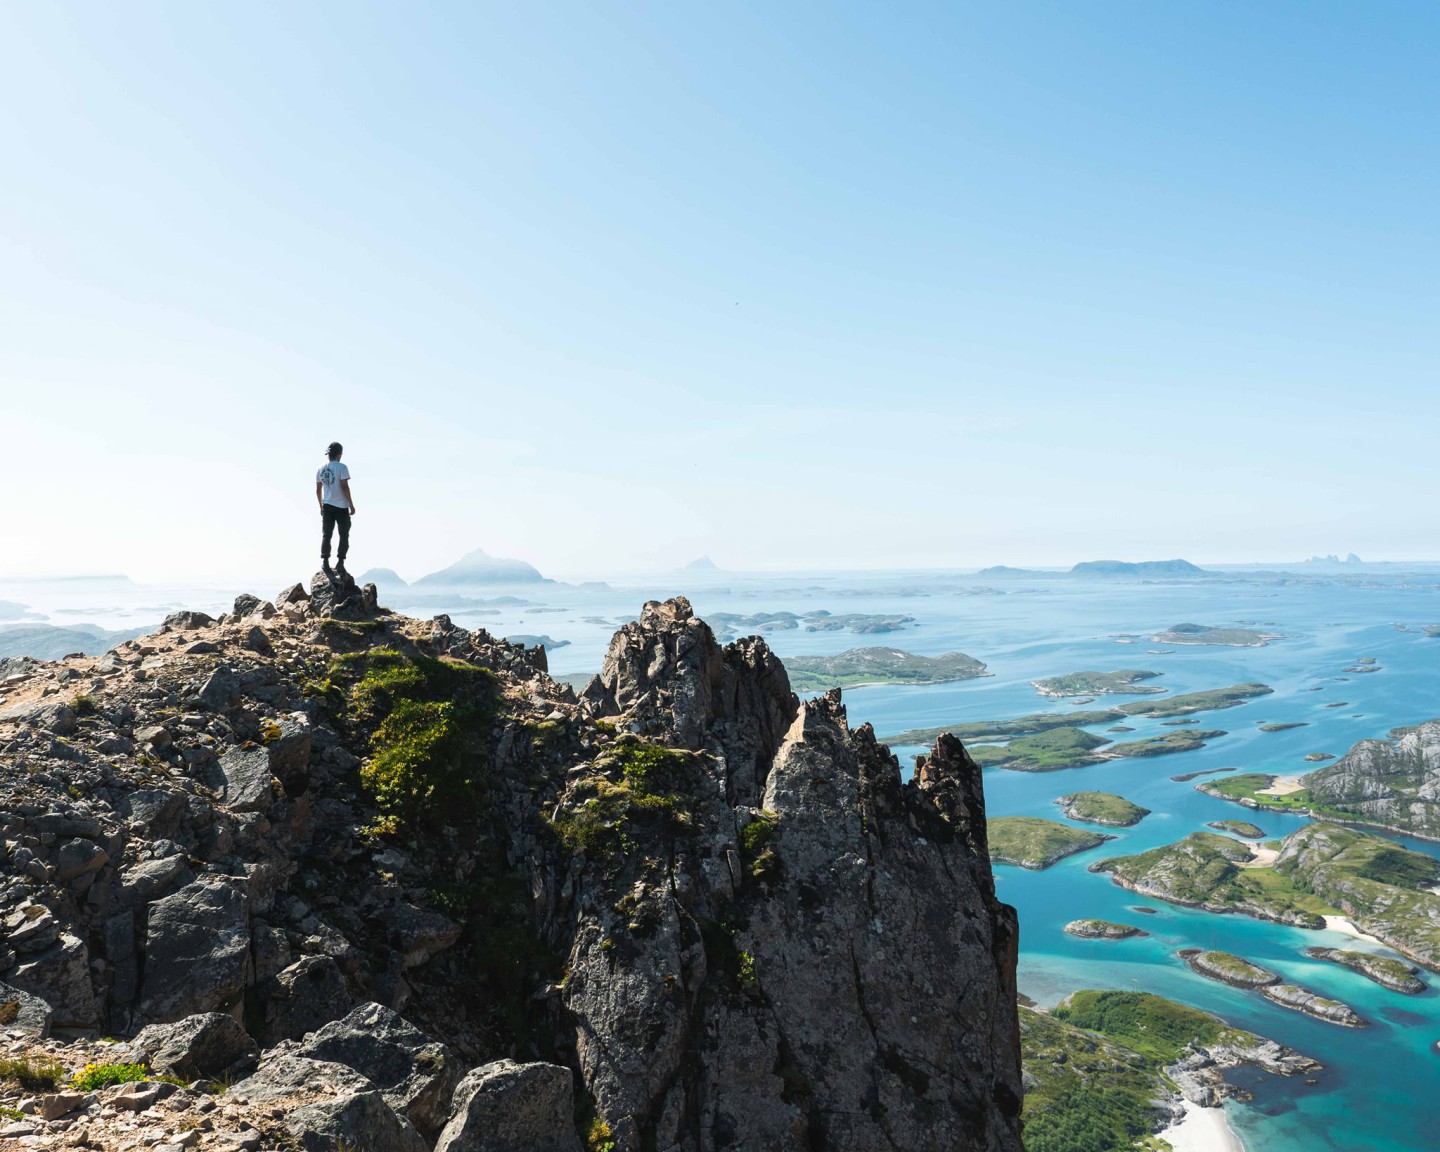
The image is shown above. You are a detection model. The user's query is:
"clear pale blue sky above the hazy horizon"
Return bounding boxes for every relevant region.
[0,0,1440,579]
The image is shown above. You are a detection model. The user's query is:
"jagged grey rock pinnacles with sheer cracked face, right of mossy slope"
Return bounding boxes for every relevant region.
[557,600,1021,1151]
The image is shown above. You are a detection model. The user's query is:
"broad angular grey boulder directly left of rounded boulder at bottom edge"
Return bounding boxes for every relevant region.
[298,1002,461,1136]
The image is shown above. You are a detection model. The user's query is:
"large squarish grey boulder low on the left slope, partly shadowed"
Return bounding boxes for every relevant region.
[140,880,251,1022]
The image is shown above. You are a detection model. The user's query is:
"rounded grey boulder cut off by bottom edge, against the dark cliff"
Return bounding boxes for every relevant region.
[435,1060,582,1152]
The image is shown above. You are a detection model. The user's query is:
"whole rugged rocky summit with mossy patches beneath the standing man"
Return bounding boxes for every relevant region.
[0,575,1021,1152]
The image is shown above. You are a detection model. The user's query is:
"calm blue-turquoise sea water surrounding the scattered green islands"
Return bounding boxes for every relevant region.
[0,569,1440,1152]
